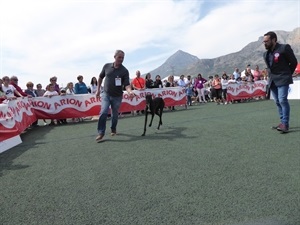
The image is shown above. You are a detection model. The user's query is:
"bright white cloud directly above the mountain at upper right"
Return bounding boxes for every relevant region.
[182,0,300,58]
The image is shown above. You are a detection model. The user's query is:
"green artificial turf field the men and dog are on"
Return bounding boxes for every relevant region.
[0,100,300,225]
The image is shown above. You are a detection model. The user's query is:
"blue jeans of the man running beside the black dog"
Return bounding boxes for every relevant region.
[98,92,123,135]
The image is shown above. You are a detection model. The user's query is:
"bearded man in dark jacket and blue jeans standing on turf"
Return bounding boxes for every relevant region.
[263,31,297,133]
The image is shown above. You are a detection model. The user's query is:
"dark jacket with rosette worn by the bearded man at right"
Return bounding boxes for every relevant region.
[264,43,297,87]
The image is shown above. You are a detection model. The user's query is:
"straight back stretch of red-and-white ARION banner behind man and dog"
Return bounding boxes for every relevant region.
[32,87,186,119]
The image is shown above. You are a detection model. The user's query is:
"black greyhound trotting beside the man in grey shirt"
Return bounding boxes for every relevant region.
[142,94,165,136]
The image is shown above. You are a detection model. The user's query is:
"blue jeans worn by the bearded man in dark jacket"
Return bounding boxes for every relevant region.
[270,84,290,126]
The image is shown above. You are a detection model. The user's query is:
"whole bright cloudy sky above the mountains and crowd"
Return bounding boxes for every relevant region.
[0,0,300,88]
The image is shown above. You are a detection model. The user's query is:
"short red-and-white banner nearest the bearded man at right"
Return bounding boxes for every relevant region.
[227,80,267,101]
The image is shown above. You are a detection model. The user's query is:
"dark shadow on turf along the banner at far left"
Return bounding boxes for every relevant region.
[0,126,52,177]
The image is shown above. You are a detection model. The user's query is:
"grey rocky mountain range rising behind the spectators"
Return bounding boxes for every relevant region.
[150,27,300,78]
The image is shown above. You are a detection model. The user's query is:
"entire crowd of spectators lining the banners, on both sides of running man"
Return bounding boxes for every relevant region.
[0,65,298,125]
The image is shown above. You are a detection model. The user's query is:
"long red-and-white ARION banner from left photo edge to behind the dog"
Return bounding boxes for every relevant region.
[0,87,186,142]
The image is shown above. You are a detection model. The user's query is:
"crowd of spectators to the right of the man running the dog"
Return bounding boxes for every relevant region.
[132,65,269,107]
